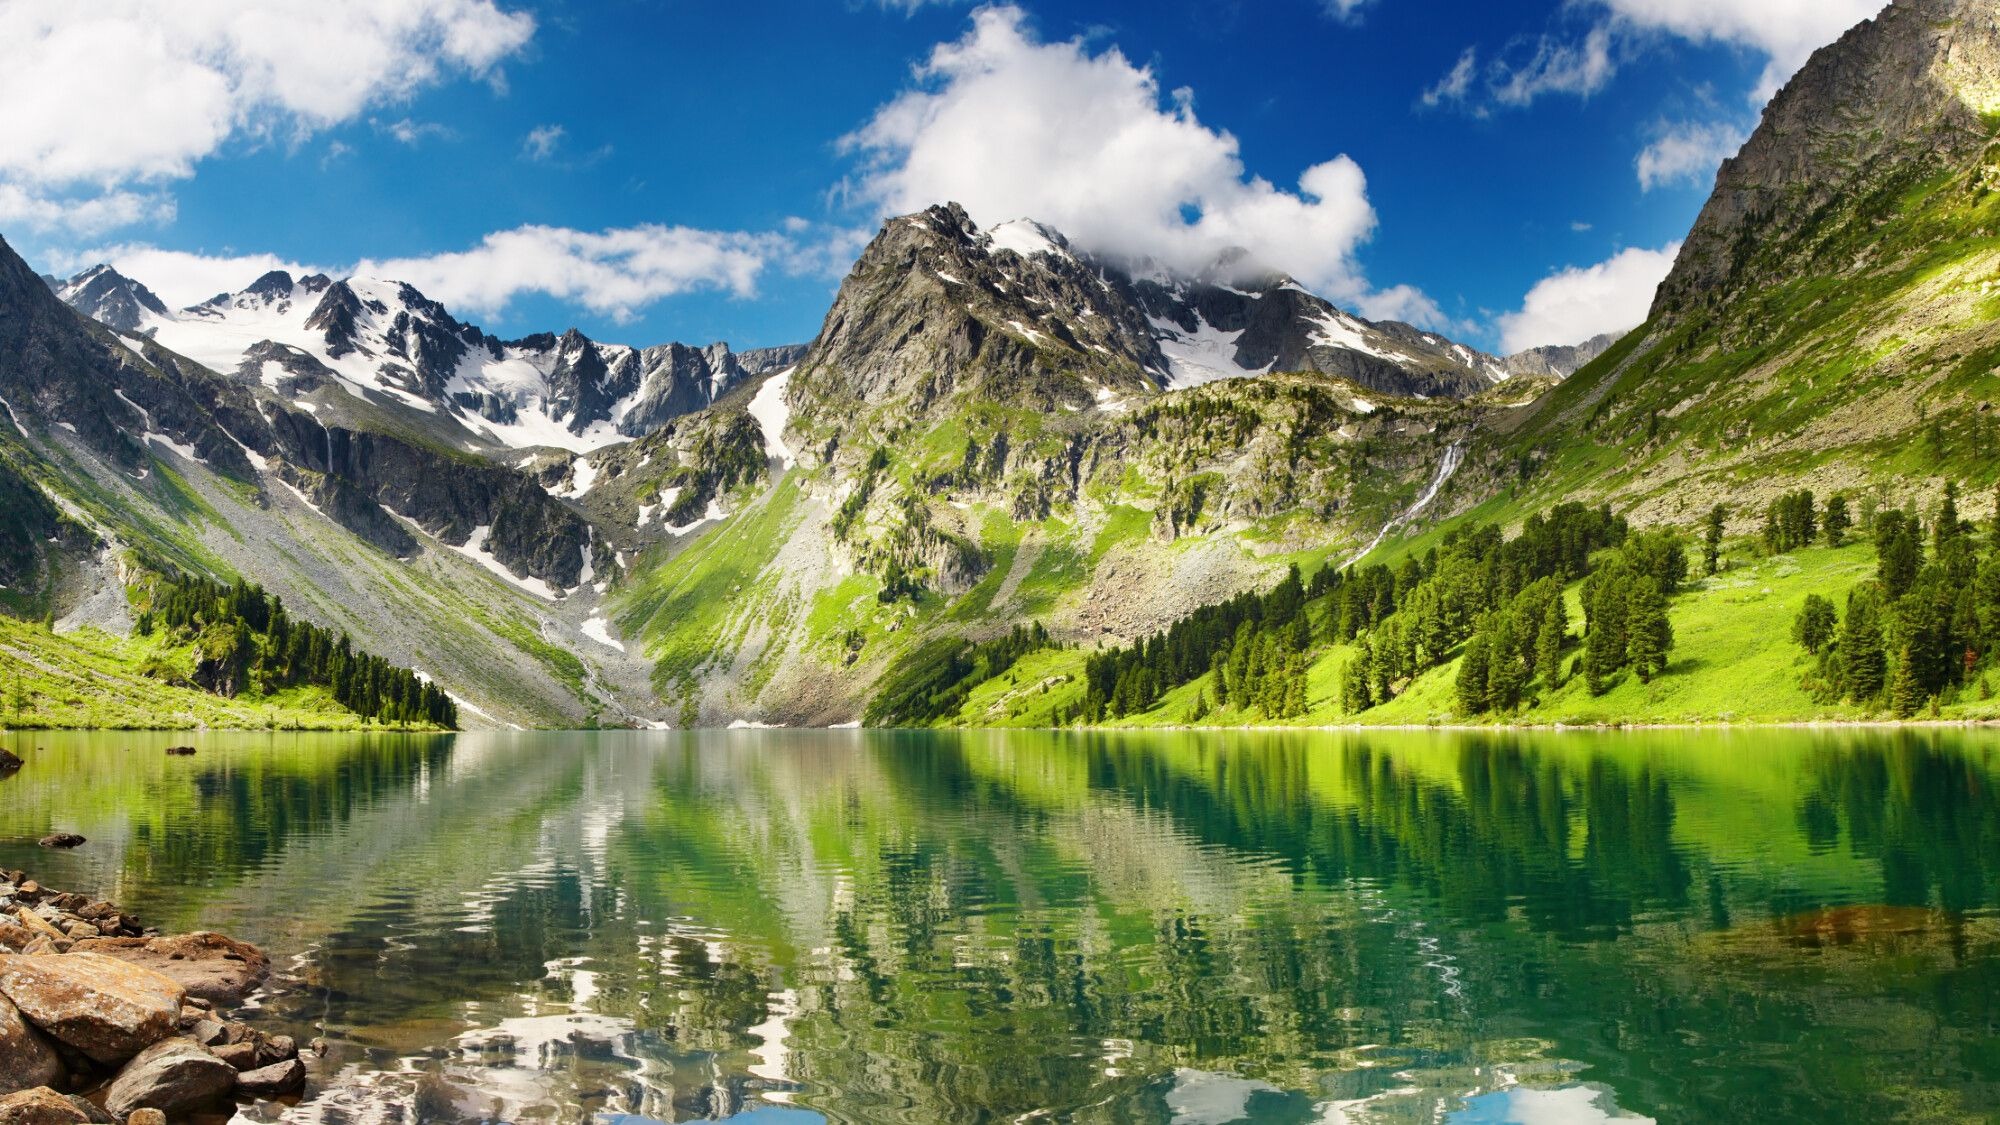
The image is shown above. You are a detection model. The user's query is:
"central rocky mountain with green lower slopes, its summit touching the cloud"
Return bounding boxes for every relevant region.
[608,204,1518,723]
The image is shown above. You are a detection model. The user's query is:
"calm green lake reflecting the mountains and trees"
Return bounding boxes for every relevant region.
[0,729,2000,1125]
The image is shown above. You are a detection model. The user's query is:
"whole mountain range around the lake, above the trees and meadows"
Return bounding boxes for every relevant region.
[0,0,2000,727]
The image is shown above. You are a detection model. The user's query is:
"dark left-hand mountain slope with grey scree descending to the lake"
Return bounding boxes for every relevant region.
[0,242,676,725]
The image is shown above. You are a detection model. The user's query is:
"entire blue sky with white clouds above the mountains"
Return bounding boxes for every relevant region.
[0,0,1872,348]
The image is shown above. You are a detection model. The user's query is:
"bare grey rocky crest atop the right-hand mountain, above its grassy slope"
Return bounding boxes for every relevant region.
[1652,0,2000,316]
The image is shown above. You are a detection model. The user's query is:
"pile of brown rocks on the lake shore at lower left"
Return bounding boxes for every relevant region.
[0,871,306,1125]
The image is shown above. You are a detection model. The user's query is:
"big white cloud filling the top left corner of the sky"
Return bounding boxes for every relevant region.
[0,0,534,226]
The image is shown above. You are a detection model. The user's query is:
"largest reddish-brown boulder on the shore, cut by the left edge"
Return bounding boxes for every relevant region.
[0,953,186,1063]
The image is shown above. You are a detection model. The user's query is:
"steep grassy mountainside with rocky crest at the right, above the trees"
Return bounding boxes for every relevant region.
[1468,0,2000,530]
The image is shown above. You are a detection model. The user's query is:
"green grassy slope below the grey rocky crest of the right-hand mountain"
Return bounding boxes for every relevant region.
[1468,141,2000,524]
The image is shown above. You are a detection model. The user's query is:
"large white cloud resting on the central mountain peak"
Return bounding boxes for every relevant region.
[842,6,1416,302]
